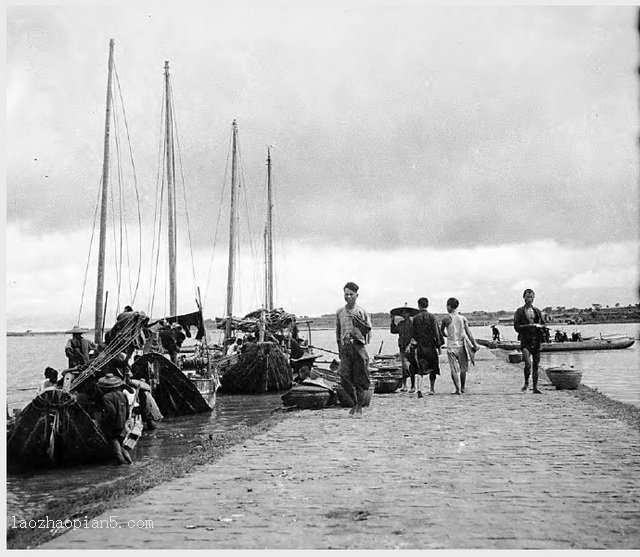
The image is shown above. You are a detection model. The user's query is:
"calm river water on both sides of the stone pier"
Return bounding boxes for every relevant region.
[6,323,640,520]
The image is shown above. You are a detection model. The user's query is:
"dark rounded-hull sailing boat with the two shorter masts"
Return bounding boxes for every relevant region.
[216,125,293,394]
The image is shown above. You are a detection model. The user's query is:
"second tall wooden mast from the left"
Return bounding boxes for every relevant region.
[164,61,178,315]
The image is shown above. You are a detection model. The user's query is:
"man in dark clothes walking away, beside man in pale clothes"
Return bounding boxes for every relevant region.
[411,298,444,398]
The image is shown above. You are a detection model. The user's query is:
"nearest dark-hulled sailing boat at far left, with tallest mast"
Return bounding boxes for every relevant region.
[7,39,138,466]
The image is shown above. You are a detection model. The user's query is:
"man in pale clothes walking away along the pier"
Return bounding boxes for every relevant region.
[440,298,480,395]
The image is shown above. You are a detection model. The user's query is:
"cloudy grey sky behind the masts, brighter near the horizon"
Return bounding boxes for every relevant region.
[5,1,639,330]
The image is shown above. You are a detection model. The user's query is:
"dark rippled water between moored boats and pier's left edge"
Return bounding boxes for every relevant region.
[7,393,282,524]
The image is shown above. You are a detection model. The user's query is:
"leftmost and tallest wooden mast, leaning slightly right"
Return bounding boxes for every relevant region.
[94,39,114,343]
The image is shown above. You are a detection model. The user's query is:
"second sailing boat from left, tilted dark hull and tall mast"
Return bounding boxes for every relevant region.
[132,61,220,416]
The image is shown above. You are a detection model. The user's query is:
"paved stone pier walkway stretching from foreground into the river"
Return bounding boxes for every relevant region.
[41,349,640,549]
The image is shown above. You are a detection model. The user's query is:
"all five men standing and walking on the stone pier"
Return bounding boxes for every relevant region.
[336,282,545,417]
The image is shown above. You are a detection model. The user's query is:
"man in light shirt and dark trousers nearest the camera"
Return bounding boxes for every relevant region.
[336,282,371,418]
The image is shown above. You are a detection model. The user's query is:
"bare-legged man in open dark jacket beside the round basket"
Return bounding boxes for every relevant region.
[513,288,545,394]
